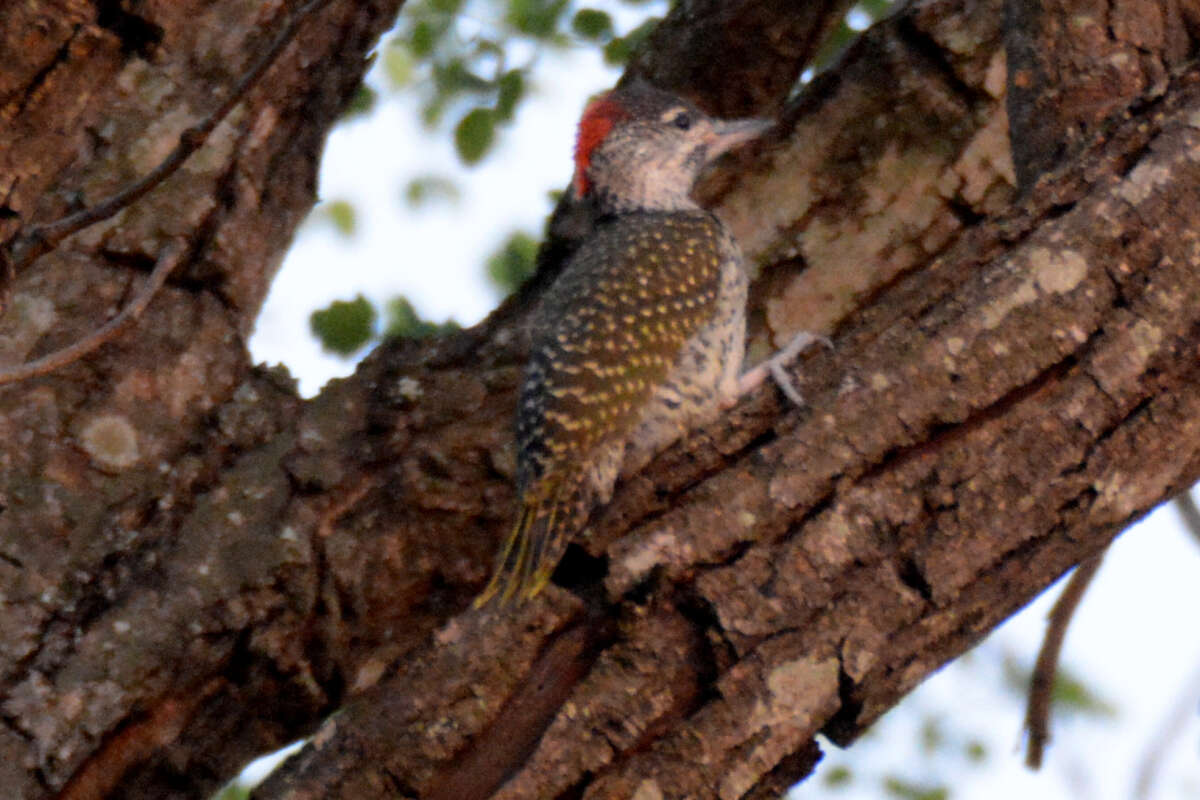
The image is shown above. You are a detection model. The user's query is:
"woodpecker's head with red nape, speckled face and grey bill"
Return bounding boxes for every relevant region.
[572,83,772,212]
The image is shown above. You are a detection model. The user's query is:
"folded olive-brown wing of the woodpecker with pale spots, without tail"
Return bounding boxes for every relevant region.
[517,212,721,497]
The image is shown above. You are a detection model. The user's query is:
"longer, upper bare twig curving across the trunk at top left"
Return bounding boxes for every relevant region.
[0,0,329,304]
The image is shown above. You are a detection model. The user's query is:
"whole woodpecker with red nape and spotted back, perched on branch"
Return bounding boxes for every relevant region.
[475,83,798,607]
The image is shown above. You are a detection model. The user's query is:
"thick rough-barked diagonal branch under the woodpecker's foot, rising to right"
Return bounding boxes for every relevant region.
[257,45,1200,798]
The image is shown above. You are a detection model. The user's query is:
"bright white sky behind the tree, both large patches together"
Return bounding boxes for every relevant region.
[243,7,1200,800]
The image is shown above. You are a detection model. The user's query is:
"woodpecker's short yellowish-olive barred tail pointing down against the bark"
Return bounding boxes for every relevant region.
[475,486,583,608]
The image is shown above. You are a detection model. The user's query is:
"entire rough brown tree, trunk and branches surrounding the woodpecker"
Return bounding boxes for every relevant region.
[0,0,1200,799]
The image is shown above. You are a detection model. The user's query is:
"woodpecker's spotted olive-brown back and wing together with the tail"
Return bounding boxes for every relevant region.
[476,210,725,604]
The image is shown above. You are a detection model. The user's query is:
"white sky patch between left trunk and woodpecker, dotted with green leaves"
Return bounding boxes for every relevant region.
[250,21,619,396]
